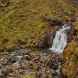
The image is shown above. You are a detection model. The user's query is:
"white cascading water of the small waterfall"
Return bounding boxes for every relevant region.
[49,24,70,53]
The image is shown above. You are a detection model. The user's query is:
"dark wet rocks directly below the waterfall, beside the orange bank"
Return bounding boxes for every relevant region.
[48,54,62,78]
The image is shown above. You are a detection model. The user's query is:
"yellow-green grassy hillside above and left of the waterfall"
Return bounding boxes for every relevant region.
[0,0,76,47]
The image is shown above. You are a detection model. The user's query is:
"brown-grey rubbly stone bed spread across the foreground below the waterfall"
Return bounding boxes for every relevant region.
[0,49,61,78]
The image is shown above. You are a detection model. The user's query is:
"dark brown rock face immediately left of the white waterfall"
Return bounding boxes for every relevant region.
[37,32,55,49]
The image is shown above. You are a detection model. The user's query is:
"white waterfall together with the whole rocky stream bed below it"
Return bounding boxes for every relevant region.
[0,24,70,78]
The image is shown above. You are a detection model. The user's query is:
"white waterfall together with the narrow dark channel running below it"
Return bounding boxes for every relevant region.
[49,24,71,78]
